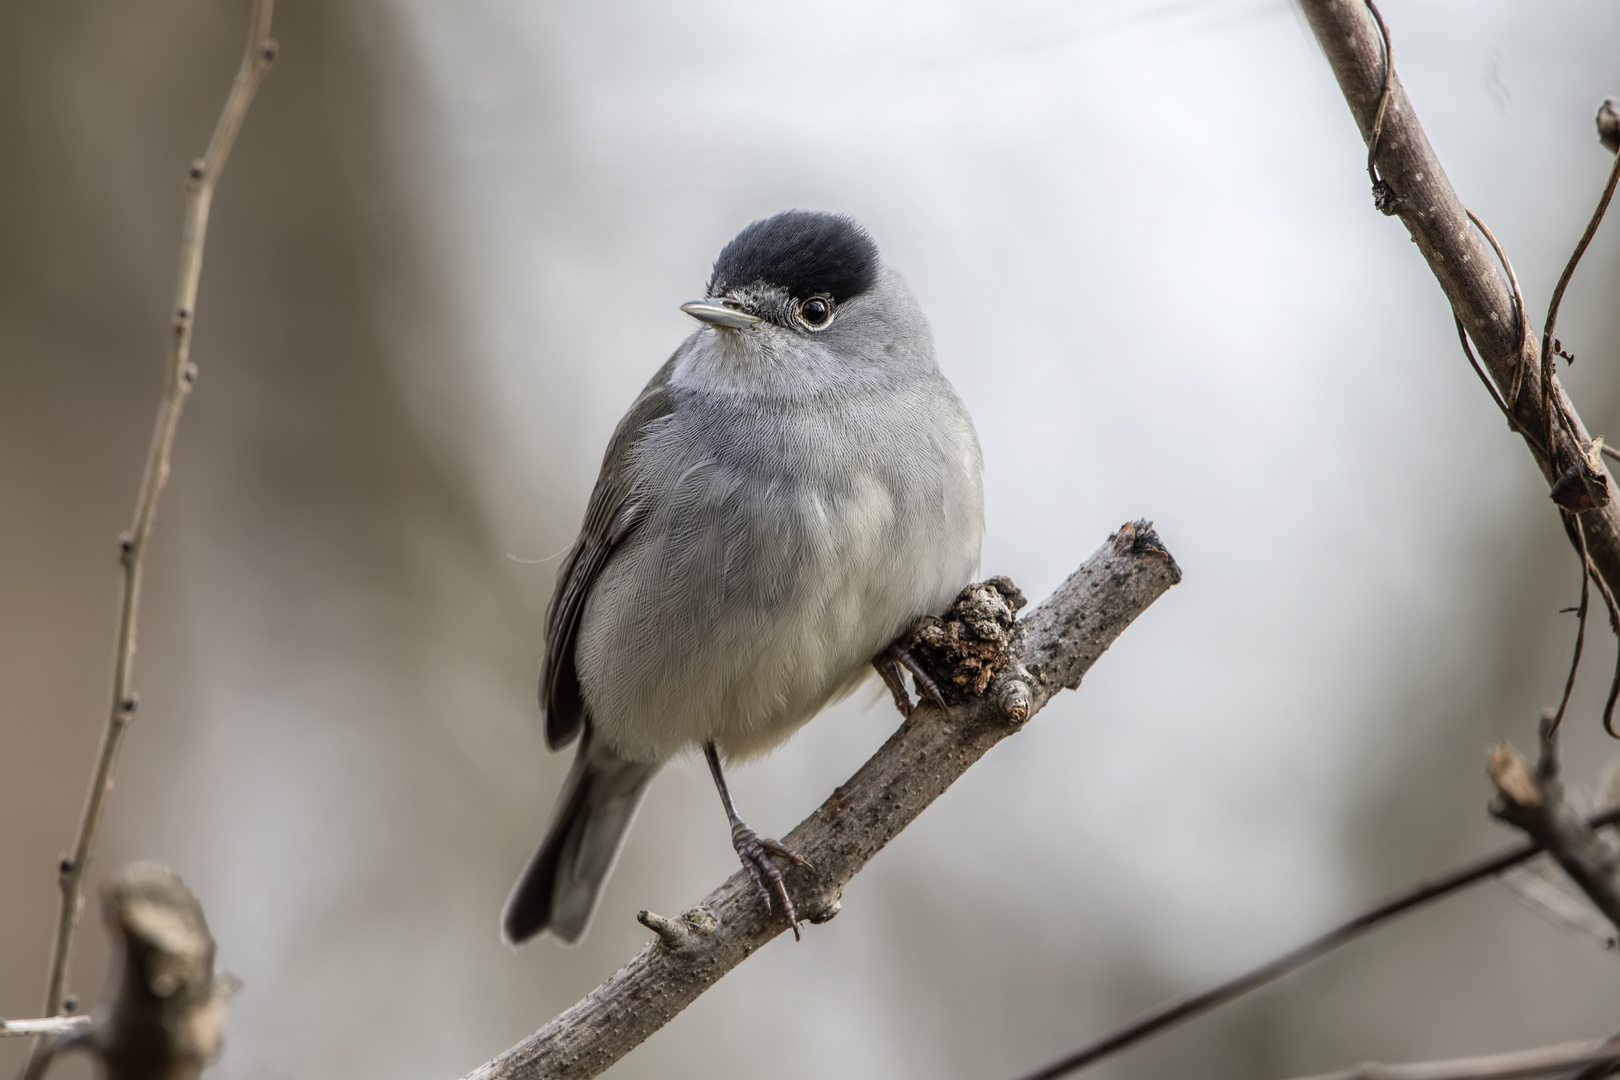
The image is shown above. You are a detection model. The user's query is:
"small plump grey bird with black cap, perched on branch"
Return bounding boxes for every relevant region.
[502,210,983,944]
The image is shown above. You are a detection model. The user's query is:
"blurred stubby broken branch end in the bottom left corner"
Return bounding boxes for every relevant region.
[94,863,237,1080]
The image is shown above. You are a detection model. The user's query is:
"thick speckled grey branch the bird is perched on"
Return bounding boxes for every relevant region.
[467,521,1181,1080]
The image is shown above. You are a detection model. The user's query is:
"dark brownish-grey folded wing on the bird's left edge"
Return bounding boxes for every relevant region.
[539,356,676,750]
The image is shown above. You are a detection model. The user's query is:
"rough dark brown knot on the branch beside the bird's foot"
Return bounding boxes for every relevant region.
[904,576,1024,704]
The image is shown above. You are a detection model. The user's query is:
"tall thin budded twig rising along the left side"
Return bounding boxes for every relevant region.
[24,0,275,1049]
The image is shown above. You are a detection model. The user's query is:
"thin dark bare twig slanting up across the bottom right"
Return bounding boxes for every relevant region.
[1024,806,1620,1080]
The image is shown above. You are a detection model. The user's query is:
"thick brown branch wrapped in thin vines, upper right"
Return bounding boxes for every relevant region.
[1301,0,1620,593]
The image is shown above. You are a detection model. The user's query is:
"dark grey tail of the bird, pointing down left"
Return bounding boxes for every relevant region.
[501,727,658,946]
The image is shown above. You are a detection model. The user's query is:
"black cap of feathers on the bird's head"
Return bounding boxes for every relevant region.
[708,210,878,303]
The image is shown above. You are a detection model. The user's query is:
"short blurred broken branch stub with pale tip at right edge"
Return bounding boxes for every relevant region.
[1489,712,1620,928]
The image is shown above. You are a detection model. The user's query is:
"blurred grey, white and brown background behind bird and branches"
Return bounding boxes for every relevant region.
[0,0,1620,1080]
